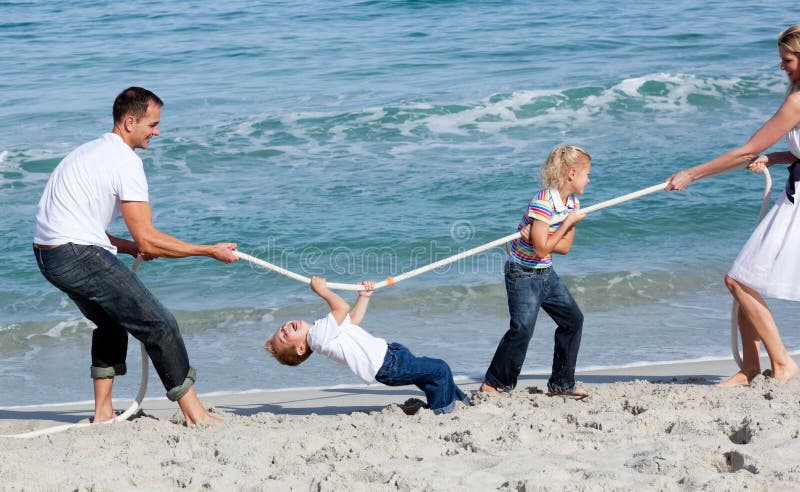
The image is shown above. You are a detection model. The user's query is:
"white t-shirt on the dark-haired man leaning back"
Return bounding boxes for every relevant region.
[33,133,148,254]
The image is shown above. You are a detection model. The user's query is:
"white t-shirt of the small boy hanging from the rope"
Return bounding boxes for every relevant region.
[306,313,388,383]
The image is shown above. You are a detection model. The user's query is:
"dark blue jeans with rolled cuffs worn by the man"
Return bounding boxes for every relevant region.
[33,243,196,401]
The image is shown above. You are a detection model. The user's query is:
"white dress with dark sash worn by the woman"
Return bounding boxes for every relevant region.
[728,124,800,301]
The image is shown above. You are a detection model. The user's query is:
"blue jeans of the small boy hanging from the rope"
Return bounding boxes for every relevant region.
[375,343,469,414]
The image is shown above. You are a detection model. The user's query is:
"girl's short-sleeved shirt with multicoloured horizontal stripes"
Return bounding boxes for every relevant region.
[509,188,580,268]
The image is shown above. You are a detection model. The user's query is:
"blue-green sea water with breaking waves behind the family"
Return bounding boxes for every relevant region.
[0,0,800,406]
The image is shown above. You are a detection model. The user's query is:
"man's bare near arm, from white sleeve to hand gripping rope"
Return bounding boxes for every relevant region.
[120,201,239,263]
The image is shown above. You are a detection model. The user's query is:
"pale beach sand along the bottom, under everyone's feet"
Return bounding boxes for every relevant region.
[0,357,800,491]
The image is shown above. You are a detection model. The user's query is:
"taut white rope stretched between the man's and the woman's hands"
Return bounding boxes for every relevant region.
[234,182,667,290]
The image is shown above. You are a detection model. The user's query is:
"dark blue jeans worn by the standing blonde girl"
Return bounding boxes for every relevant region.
[486,261,583,392]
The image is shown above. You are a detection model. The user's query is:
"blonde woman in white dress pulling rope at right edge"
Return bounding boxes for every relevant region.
[666,24,800,386]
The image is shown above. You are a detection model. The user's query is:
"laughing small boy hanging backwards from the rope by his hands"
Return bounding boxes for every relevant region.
[265,277,469,414]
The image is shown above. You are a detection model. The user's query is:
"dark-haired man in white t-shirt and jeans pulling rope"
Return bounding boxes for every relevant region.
[33,87,238,425]
